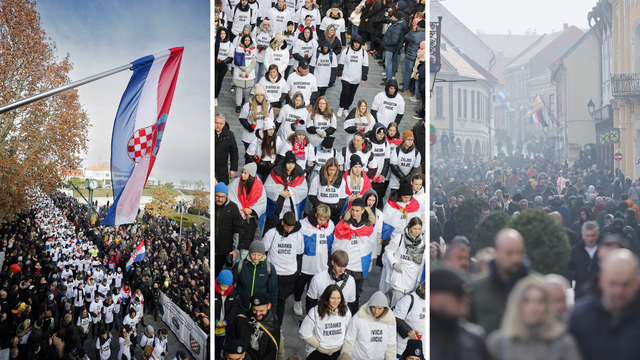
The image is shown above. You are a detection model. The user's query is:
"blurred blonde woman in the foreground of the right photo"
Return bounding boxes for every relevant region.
[486,276,582,360]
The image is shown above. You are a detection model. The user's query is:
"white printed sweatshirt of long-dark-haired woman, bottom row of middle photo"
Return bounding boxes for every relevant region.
[300,306,351,357]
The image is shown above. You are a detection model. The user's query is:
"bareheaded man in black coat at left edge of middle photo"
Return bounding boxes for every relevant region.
[214,114,238,185]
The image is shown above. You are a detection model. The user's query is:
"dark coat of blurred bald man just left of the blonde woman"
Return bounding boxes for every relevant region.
[468,260,535,333]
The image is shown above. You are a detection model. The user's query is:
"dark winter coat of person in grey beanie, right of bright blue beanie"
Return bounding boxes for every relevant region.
[232,258,278,314]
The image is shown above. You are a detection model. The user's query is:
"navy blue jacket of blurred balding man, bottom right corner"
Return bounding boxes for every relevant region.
[569,294,640,360]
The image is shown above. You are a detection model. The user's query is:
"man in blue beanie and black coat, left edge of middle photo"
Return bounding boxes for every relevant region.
[214,183,242,277]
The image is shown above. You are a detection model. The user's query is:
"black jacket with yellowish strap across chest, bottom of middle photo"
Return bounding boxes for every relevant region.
[227,311,280,360]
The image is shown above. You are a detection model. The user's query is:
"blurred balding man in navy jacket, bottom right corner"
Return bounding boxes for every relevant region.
[569,249,640,360]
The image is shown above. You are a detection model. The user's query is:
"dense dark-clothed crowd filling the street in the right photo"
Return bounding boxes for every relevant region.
[429,144,640,360]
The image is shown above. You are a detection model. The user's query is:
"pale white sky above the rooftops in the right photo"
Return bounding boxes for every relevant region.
[440,0,597,34]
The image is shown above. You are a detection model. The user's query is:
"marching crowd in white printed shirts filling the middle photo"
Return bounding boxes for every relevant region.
[214,0,428,360]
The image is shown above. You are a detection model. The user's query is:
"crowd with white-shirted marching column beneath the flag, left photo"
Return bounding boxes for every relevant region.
[0,193,210,360]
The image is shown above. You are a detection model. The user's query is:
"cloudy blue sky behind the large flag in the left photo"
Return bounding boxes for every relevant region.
[36,0,210,183]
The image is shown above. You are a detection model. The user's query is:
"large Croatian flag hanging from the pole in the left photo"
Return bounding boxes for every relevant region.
[103,47,184,225]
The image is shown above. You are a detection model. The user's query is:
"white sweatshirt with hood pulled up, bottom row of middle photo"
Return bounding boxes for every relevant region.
[342,291,396,360]
